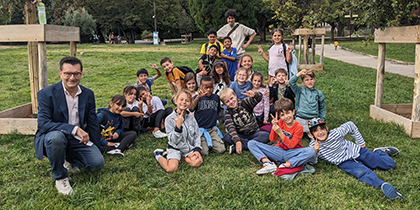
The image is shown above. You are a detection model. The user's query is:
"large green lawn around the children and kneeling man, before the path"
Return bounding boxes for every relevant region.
[0,43,420,209]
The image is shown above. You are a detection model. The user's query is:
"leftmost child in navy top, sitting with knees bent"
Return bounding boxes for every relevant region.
[97,95,137,157]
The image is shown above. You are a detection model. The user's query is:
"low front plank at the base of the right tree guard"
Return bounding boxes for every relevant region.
[369,105,412,135]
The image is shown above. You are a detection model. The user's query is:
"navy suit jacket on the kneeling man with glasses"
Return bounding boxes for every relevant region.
[35,82,101,160]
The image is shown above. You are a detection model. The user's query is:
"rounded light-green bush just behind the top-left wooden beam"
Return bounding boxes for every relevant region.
[63,7,96,35]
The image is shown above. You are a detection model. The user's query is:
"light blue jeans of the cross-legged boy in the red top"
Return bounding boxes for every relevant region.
[248,141,316,168]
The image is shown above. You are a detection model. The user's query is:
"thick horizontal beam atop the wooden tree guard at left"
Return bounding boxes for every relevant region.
[0,24,80,42]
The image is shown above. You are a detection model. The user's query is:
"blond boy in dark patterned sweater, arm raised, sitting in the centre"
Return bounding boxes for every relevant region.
[220,87,270,154]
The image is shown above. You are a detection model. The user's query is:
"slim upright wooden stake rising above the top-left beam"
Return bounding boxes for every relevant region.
[24,1,39,118]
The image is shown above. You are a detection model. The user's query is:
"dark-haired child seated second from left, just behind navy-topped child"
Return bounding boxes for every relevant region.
[121,85,144,133]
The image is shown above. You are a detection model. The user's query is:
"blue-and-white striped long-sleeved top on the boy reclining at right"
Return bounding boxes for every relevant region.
[309,121,365,165]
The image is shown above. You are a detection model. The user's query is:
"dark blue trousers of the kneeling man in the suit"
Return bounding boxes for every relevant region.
[44,131,105,180]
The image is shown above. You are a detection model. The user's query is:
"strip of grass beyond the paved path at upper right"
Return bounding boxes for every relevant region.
[339,41,416,63]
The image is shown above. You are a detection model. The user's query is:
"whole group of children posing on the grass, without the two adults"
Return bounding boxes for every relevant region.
[98,29,404,199]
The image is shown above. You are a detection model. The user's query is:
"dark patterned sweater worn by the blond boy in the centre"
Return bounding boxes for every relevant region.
[225,92,262,143]
